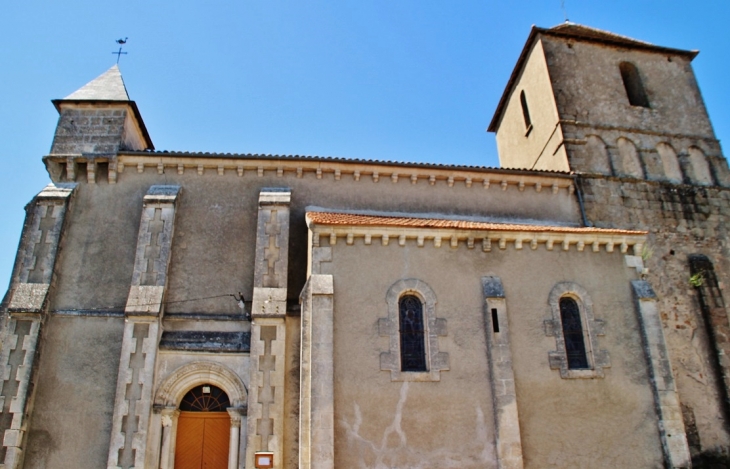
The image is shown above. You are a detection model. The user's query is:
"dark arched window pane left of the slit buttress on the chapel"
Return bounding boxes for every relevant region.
[398,295,427,371]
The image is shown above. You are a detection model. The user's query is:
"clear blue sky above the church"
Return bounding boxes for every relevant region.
[0,0,730,285]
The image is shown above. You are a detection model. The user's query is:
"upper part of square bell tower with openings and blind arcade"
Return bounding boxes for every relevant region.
[488,23,730,186]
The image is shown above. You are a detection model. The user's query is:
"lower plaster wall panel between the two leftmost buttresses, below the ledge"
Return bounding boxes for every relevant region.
[25,316,124,468]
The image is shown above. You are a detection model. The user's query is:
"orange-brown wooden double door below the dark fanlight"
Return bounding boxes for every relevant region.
[175,412,231,469]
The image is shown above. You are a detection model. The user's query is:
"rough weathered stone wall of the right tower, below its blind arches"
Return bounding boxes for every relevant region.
[583,177,730,455]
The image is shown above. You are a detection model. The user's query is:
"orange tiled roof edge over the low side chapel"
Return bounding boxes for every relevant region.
[307,212,646,235]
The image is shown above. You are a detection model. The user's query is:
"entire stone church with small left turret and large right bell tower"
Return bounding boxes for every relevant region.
[0,23,730,469]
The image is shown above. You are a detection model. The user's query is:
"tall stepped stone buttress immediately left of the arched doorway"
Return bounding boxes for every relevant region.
[107,186,180,469]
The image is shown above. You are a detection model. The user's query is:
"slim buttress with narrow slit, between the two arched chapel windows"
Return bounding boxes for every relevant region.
[482,277,523,469]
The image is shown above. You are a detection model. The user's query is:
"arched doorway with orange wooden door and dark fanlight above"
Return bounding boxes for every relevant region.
[175,384,231,469]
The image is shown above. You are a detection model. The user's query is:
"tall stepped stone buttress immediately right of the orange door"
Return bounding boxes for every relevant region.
[246,188,291,467]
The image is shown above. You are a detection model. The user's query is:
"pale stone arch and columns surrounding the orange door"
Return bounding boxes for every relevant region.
[148,361,248,469]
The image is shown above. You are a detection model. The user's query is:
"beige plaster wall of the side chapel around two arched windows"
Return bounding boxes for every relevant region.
[321,238,662,468]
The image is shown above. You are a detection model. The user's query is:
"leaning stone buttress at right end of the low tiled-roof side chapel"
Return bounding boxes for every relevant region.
[631,280,692,468]
